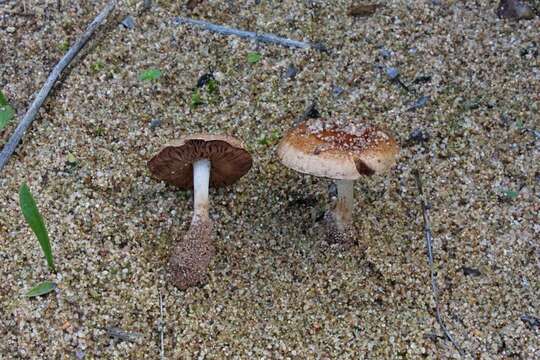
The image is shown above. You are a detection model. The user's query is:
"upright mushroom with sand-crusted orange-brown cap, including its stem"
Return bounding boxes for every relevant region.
[277,119,399,245]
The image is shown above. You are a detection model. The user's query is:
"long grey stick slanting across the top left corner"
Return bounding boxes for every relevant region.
[0,0,117,170]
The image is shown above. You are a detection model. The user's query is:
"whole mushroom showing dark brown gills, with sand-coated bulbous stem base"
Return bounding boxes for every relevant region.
[148,134,252,289]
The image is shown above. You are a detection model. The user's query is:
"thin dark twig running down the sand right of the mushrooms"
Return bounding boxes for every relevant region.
[413,170,465,357]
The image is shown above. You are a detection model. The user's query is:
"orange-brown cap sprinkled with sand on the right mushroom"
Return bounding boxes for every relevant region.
[277,119,399,180]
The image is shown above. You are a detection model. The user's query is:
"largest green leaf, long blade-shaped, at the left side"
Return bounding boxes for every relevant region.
[19,184,55,272]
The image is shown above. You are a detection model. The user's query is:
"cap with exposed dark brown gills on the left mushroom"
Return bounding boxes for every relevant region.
[148,134,252,189]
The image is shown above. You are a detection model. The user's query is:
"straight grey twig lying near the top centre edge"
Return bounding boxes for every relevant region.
[173,17,328,52]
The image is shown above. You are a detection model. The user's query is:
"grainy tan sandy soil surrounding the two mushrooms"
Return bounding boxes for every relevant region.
[0,0,540,359]
